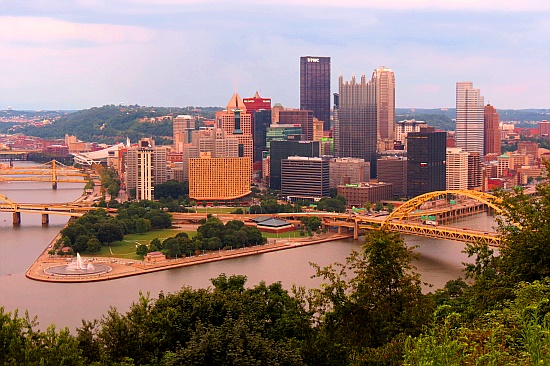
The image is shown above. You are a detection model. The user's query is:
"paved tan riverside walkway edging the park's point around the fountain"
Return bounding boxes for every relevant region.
[25,233,353,283]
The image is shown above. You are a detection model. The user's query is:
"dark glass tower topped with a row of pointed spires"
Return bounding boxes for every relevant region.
[334,75,377,177]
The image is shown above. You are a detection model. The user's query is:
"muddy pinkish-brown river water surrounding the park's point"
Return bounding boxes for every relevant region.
[0,166,492,331]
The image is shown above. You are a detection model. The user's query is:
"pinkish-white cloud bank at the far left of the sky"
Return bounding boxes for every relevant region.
[0,16,154,47]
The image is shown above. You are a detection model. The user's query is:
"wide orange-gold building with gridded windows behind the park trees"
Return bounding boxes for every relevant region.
[189,152,251,203]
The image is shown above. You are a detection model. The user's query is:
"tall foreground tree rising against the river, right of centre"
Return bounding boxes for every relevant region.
[312,231,432,364]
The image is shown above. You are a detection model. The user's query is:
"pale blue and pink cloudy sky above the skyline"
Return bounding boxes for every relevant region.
[0,0,550,110]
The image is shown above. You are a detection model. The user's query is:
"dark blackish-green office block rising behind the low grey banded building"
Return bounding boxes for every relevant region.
[269,140,320,189]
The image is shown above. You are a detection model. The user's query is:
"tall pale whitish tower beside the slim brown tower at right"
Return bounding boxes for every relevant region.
[455,81,484,156]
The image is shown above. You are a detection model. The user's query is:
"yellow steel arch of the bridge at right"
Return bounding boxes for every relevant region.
[381,190,502,229]
